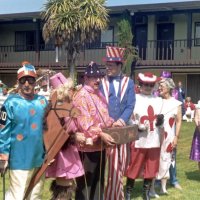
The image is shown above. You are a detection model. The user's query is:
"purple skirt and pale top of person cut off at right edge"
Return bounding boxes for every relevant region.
[190,108,200,162]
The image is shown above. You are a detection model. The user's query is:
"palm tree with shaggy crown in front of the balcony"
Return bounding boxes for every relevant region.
[42,0,108,78]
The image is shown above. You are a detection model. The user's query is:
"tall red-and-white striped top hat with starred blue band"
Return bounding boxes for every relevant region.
[103,46,125,62]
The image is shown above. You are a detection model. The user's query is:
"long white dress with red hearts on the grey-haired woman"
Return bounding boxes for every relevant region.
[157,97,182,179]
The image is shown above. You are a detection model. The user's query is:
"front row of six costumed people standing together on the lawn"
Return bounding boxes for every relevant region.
[0,47,197,200]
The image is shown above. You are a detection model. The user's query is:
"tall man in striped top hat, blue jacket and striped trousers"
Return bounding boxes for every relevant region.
[100,46,135,200]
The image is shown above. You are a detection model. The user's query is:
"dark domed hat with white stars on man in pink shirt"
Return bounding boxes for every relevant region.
[85,61,104,77]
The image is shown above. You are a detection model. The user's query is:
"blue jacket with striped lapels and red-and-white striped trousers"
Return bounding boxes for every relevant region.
[102,75,135,199]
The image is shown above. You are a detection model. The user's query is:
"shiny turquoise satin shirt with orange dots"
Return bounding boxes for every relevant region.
[0,94,48,170]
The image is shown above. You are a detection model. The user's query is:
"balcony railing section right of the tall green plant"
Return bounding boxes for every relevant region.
[137,38,200,66]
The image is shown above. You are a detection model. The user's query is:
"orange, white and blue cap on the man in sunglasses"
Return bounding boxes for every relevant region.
[17,61,37,79]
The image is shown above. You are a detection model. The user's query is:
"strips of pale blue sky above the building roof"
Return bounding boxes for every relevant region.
[0,0,197,14]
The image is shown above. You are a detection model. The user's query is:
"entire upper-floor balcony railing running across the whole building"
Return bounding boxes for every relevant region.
[0,39,200,69]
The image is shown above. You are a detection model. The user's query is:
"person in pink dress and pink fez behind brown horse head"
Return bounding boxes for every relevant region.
[44,73,84,199]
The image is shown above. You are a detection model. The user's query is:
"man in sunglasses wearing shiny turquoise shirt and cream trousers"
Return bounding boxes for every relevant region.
[0,62,47,200]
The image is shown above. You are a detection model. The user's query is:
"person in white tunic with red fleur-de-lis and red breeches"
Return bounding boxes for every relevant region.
[126,72,164,200]
